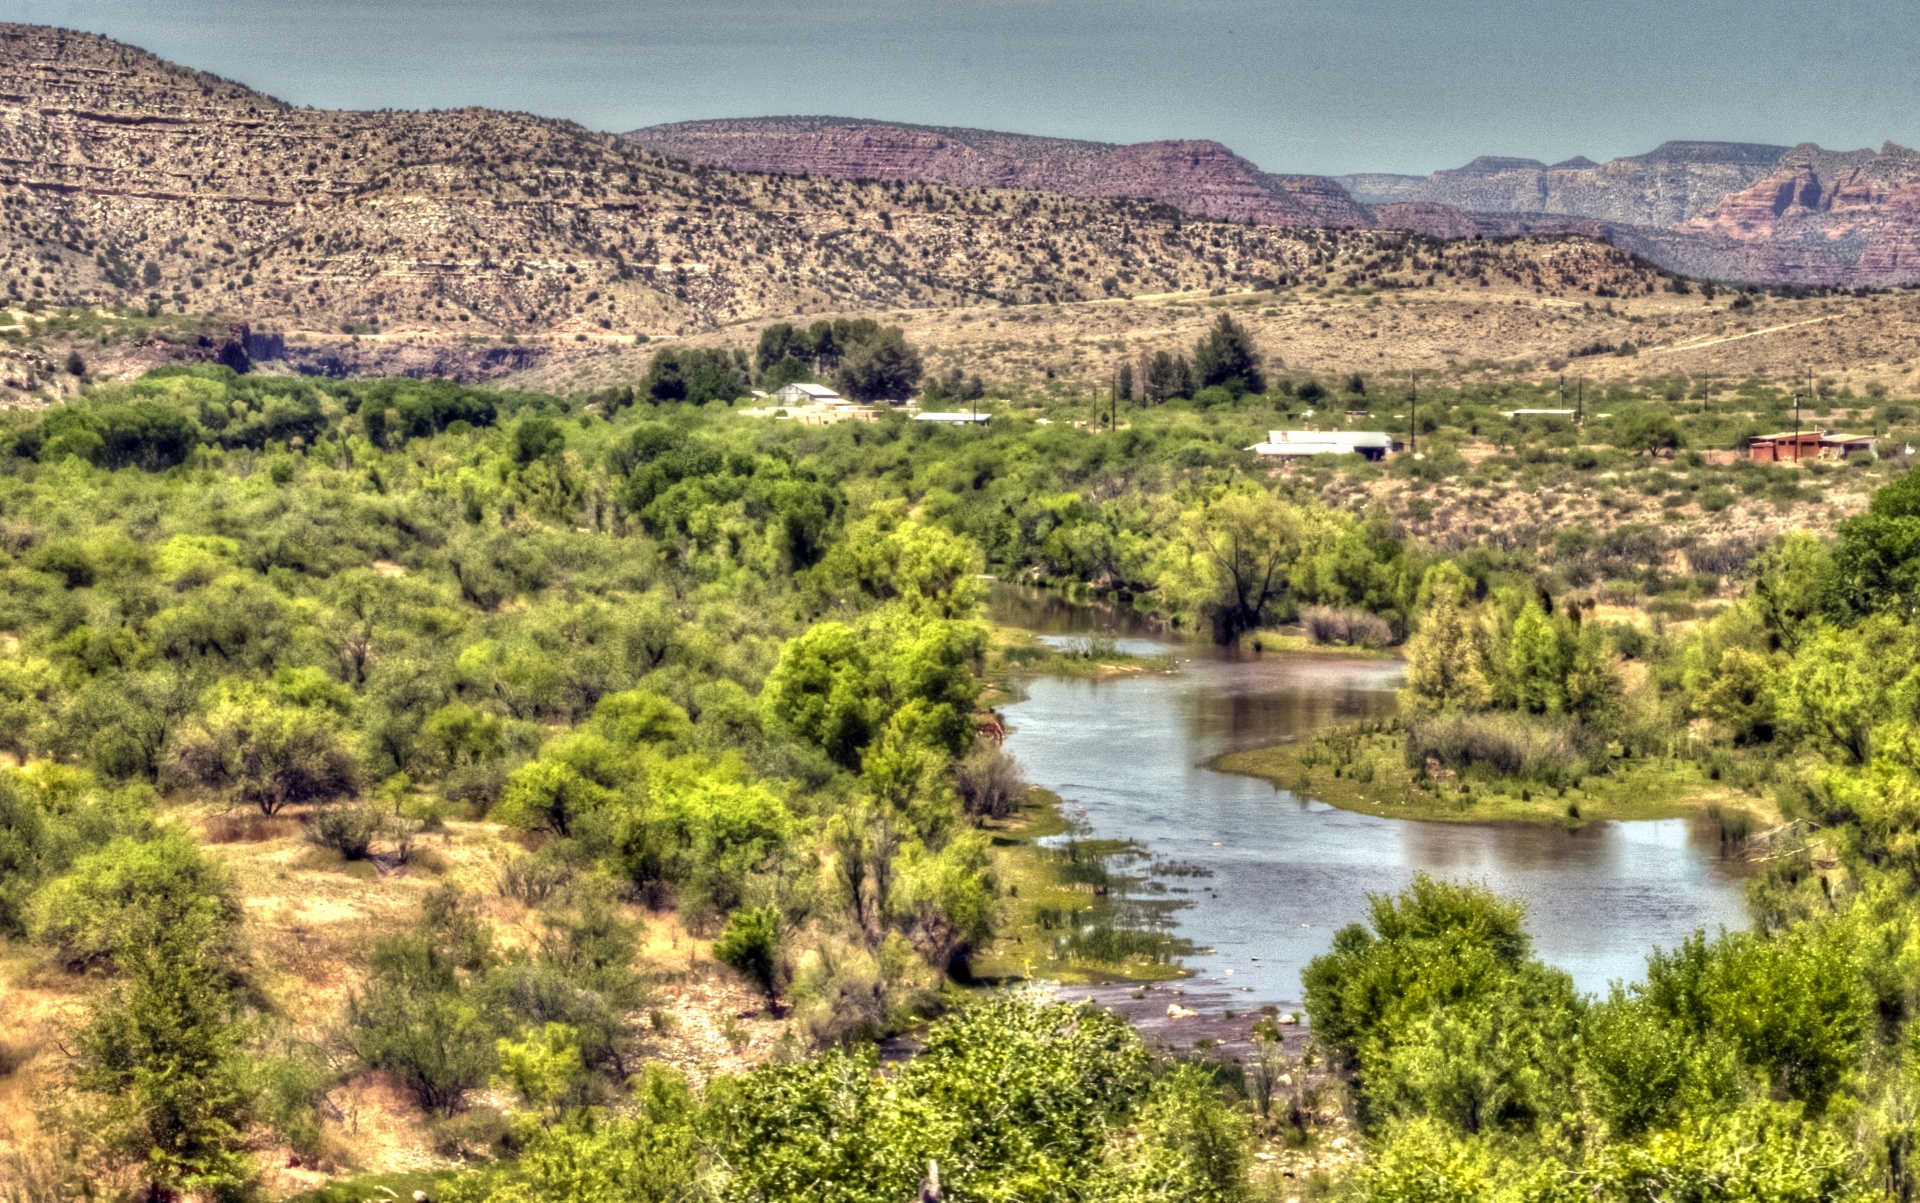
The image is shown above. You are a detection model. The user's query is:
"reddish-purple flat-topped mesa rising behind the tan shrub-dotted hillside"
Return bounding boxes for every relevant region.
[626,117,1373,226]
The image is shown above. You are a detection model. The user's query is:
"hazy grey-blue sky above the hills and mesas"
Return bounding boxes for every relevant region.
[0,0,1920,175]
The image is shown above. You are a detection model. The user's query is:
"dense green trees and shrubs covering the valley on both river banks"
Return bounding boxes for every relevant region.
[11,331,1920,1201]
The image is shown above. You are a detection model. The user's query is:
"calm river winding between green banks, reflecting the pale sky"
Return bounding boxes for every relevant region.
[993,585,1745,1003]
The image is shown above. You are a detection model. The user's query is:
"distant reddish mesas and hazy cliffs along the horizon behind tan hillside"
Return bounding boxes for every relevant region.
[626,117,1920,286]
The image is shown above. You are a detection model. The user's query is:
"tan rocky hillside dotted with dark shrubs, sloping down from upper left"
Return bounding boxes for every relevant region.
[0,25,1428,345]
